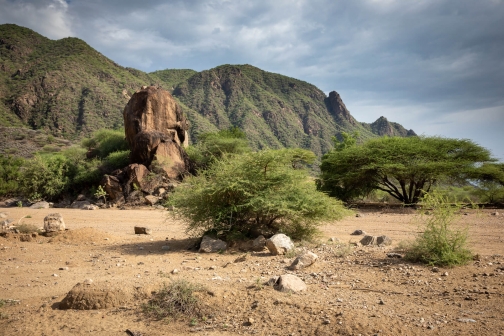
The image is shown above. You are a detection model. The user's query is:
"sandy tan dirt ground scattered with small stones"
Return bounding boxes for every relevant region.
[0,208,504,336]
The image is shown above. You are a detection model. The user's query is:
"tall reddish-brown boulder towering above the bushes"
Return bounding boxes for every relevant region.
[123,86,189,179]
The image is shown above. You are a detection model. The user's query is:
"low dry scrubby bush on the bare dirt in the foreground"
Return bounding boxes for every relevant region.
[143,280,205,320]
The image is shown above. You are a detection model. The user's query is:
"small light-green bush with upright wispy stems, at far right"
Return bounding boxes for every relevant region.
[405,193,472,266]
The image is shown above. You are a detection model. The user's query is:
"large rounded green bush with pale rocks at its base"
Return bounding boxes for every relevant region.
[169,149,347,240]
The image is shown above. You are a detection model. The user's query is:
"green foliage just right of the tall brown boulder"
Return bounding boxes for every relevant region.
[186,127,250,169]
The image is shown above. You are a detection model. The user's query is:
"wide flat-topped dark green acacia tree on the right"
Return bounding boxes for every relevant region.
[317,136,494,205]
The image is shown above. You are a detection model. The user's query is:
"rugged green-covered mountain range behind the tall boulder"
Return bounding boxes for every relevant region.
[0,24,414,155]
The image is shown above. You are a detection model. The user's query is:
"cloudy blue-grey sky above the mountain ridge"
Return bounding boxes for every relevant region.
[0,0,504,161]
